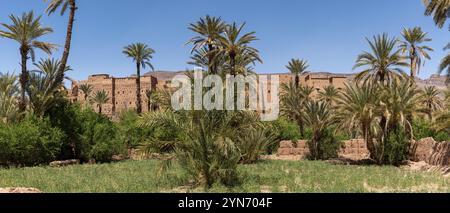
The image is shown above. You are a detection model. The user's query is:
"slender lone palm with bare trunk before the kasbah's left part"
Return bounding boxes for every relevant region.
[123,43,155,114]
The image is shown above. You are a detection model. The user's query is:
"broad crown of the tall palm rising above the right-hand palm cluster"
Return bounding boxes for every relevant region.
[354,34,408,84]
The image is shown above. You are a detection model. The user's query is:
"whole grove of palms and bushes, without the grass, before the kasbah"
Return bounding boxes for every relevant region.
[0,0,450,188]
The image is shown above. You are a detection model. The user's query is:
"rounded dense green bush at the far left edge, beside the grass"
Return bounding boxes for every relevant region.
[0,116,64,166]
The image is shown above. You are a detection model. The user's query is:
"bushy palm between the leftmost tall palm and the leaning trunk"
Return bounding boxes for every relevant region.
[28,59,70,117]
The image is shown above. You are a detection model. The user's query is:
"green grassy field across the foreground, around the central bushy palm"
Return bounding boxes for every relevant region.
[0,161,450,192]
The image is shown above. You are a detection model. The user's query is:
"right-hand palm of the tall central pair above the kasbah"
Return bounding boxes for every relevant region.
[219,23,262,76]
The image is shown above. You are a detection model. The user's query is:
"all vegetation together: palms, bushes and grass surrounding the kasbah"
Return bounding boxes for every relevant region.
[0,0,450,192]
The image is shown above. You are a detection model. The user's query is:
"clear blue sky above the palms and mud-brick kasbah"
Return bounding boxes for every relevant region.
[0,0,450,79]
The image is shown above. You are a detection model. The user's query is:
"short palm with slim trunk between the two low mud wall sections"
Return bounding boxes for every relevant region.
[304,101,334,160]
